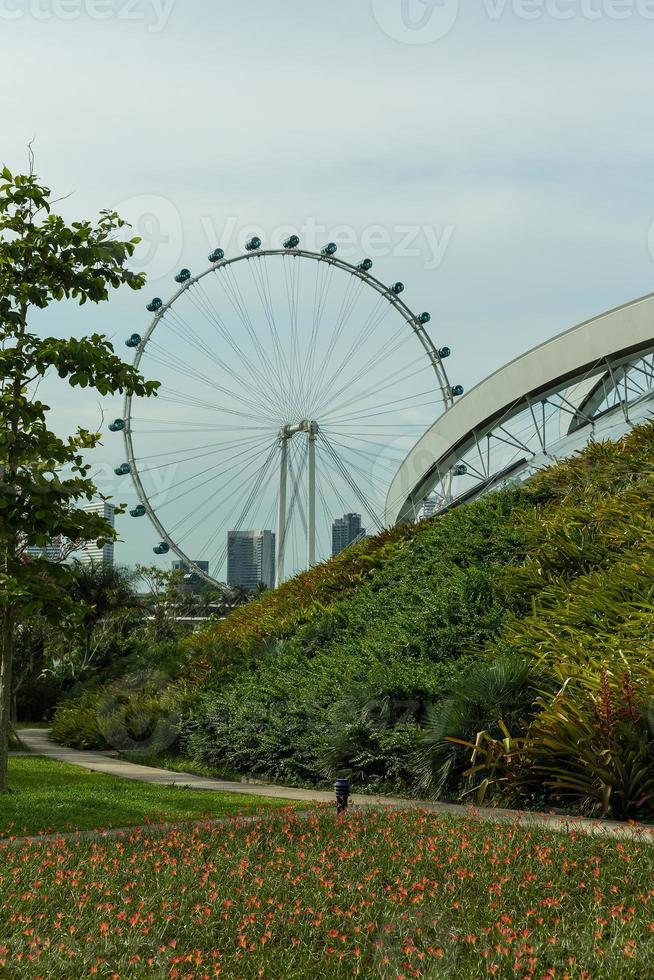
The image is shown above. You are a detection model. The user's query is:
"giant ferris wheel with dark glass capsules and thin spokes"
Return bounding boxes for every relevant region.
[109,235,463,588]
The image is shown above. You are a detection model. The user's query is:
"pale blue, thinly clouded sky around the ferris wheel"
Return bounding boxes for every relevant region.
[0,0,654,576]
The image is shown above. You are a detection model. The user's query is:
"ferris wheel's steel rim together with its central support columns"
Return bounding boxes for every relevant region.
[117,249,458,588]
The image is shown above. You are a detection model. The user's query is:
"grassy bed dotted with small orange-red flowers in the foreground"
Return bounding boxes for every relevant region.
[0,808,654,980]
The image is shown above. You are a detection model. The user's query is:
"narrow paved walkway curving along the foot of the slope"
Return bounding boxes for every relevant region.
[14,728,654,844]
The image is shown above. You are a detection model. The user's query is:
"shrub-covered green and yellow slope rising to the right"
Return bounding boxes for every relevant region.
[55,424,654,814]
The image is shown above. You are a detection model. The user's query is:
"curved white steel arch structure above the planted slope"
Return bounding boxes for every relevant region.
[385,294,654,525]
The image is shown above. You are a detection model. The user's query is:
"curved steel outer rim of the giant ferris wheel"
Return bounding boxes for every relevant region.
[123,248,454,596]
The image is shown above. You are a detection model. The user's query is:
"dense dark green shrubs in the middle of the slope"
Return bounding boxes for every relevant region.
[182,492,523,789]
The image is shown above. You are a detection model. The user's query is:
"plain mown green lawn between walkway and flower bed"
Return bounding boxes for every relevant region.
[0,756,302,840]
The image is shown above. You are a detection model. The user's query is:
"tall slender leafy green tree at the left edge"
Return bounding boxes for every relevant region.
[0,167,158,792]
